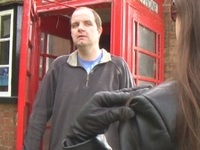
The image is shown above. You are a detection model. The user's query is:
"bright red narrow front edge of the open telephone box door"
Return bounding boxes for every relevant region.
[16,0,31,150]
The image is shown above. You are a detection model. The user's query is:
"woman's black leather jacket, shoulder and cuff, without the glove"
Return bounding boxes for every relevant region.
[63,81,177,150]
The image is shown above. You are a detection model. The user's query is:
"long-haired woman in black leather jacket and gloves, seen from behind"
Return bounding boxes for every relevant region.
[63,0,200,150]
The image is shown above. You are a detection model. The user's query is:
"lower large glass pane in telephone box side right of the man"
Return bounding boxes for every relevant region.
[139,53,156,78]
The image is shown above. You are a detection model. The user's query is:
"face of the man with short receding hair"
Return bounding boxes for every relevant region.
[71,8,102,47]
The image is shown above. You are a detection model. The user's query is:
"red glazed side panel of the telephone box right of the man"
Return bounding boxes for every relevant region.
[123,0,164,85]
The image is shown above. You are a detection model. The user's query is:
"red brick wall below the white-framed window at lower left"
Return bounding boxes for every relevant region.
[0,104,17,150]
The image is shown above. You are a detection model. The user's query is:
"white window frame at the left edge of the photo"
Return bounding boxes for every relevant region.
[0,9,14,97]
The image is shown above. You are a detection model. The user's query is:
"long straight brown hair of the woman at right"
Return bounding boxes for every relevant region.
[174,0,200,150]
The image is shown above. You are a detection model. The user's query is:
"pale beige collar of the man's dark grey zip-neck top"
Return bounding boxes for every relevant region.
[67,48,111,66]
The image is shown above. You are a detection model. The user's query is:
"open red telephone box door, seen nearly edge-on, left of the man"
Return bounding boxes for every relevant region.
[16,0,40,150]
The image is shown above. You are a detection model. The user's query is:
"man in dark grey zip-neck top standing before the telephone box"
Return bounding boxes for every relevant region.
[23,7,133,150]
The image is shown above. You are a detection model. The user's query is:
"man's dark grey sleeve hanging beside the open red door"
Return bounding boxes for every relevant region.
[23,61,56,150]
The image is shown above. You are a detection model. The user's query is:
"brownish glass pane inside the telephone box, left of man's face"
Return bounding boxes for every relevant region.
[47,35,71,56]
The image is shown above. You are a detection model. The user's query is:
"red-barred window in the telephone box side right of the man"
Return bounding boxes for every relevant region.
[132,16,162,85]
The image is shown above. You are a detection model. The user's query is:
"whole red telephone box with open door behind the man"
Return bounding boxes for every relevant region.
[16,0,164,150]
